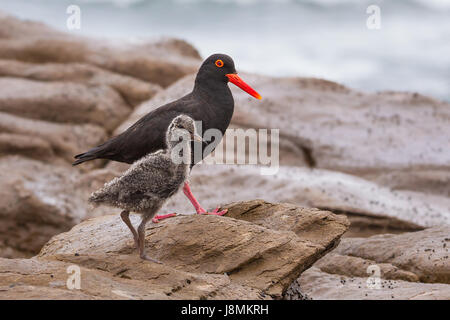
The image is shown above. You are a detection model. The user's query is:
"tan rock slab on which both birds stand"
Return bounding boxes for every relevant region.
[5,200,349,299]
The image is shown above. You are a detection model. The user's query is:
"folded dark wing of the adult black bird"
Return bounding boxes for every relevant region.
[73,94,197,165]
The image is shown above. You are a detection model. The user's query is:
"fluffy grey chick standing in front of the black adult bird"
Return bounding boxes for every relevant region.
[89,115,202,262]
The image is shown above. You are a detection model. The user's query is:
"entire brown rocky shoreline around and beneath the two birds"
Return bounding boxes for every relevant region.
[0,12,450,299]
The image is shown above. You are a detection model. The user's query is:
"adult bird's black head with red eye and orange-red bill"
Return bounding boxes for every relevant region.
[195,53,261,99]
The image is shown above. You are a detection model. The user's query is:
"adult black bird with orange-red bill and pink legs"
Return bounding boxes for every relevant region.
[73,54,261,219]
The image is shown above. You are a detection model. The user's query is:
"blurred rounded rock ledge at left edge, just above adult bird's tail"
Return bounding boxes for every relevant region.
[0,77,131,130]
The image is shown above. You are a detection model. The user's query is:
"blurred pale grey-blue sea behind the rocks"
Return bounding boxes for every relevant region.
[0,0,450,101]
